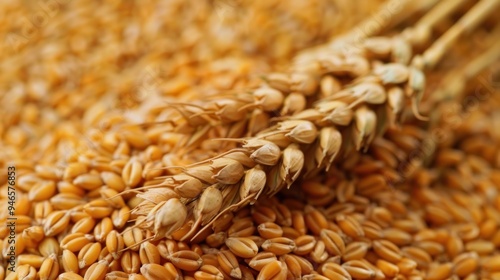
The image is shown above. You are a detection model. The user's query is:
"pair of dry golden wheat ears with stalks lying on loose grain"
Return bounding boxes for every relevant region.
[125,0,499,243]
